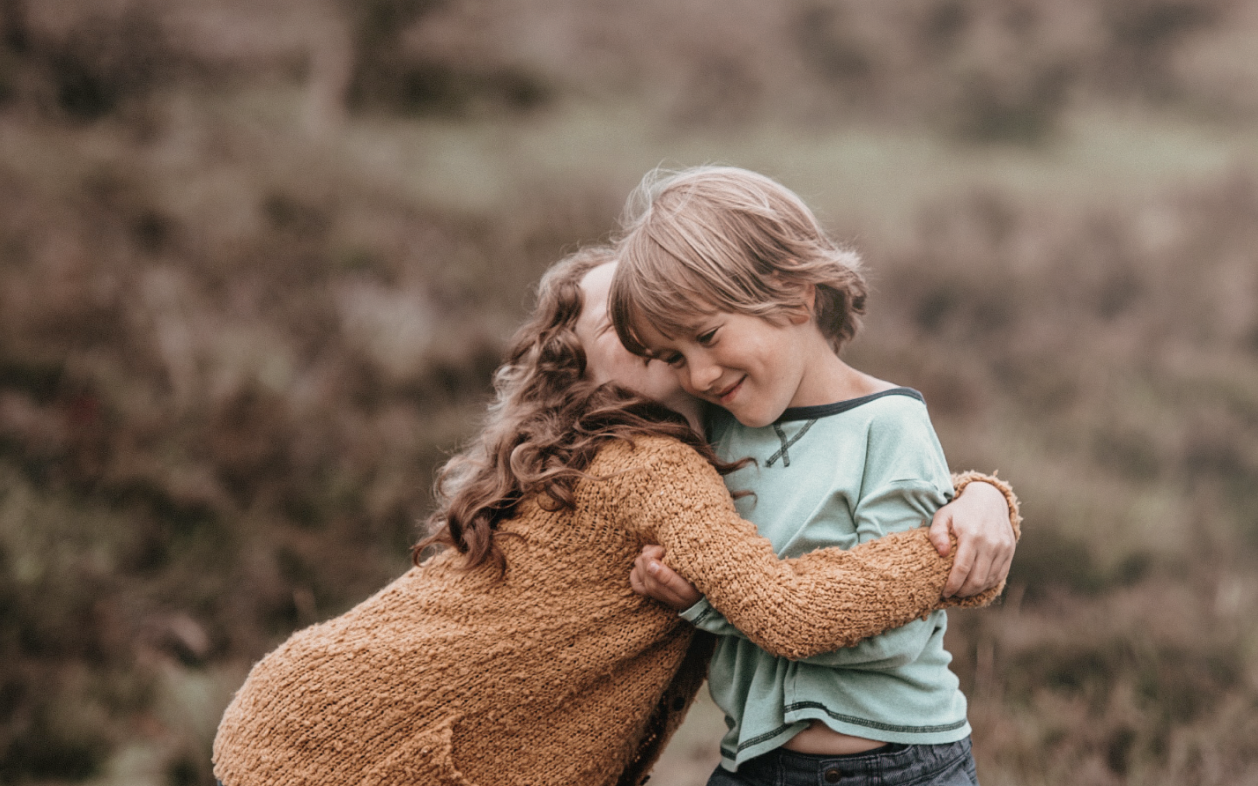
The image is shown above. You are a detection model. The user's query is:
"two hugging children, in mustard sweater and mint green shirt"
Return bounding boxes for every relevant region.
[214,162,1018,786]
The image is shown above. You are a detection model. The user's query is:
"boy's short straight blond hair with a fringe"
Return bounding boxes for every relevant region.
[608,166,866,356]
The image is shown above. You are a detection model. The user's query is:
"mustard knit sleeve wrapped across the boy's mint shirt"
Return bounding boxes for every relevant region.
[613,440,1000,660]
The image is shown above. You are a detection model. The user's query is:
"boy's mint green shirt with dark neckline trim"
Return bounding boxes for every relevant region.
[682,387,970,770]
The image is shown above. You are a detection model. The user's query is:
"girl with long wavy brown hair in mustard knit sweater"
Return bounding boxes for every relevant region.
[214,249,1008,786]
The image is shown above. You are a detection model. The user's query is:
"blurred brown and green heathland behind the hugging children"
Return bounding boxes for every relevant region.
[0,0,1258,786]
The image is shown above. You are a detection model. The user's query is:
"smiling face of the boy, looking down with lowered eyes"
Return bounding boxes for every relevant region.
[642,312,833,428]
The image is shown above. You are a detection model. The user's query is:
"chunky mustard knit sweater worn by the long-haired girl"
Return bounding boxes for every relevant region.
[214,438,1013,786]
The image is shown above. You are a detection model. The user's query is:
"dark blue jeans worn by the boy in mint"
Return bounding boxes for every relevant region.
[707,737,979,786]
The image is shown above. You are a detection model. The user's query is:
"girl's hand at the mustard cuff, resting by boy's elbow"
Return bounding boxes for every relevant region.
[930,482,1016,597]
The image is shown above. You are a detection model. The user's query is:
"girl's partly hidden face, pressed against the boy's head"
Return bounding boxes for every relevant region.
[575,263,699,423]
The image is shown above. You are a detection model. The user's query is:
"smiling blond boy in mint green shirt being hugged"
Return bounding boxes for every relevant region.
[609,167,1016,786]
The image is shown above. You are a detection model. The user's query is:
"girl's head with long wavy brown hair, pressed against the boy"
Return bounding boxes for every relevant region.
[411,246,715,567]
